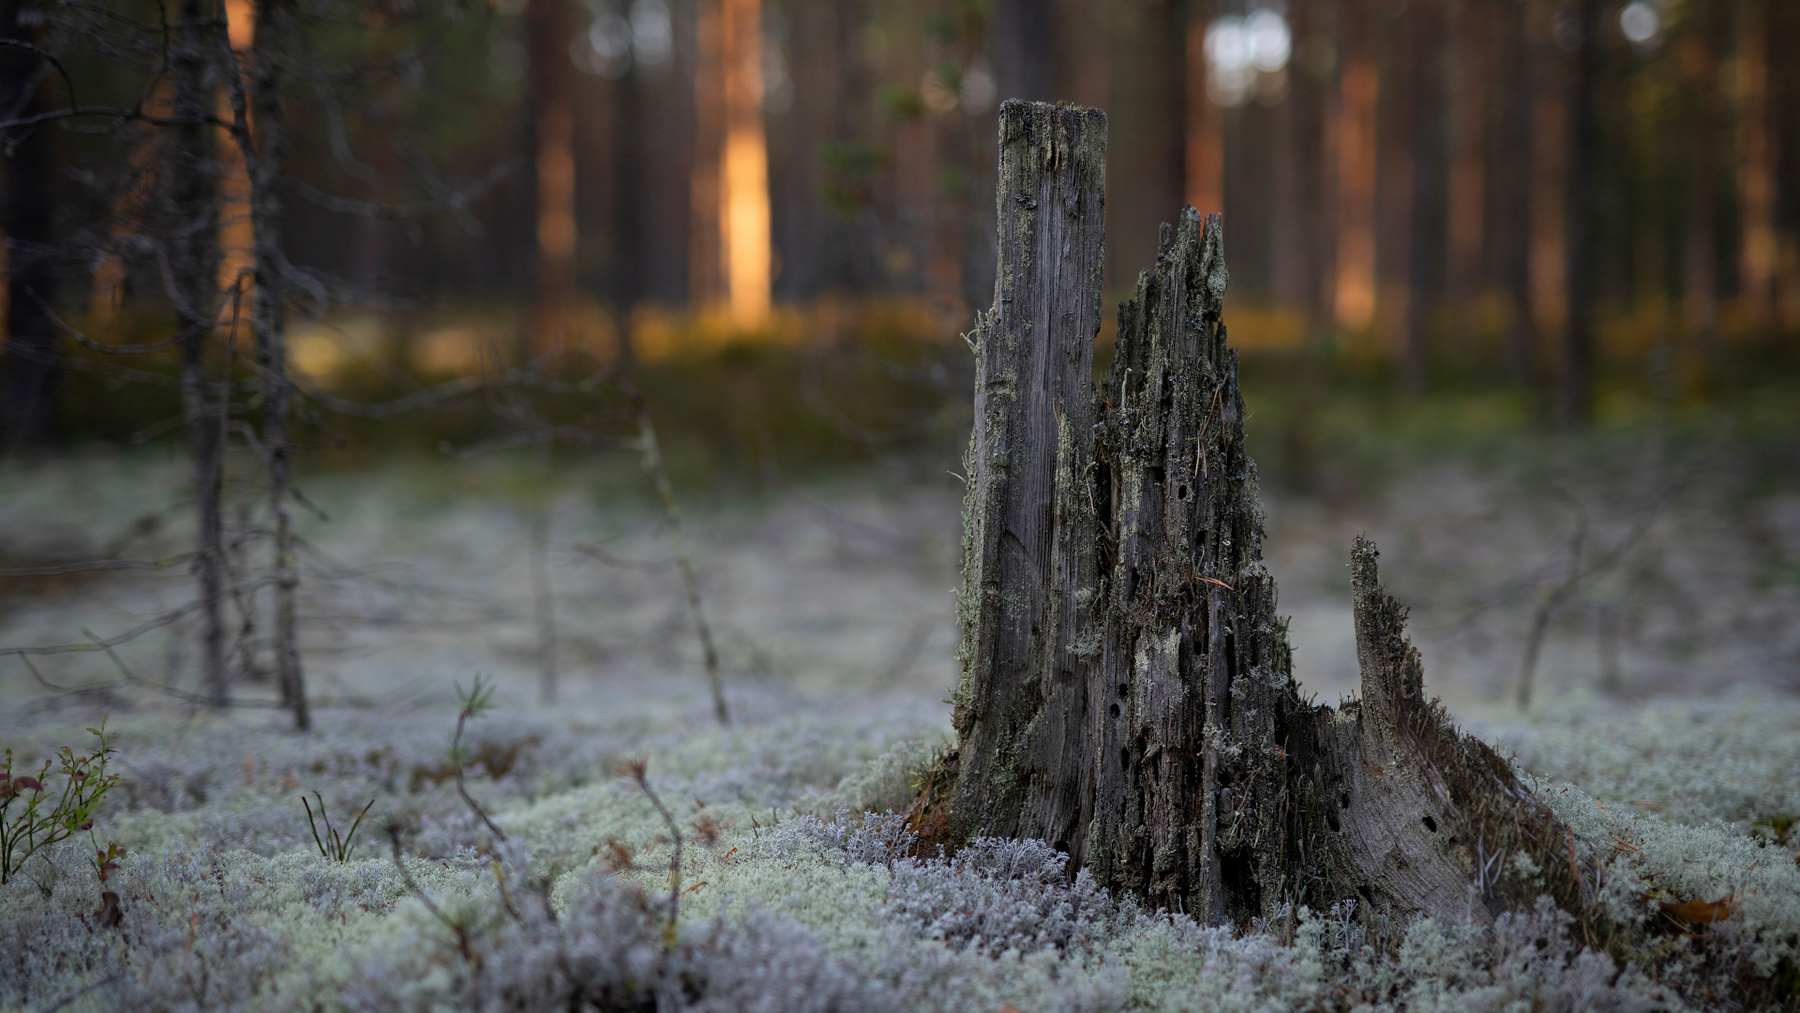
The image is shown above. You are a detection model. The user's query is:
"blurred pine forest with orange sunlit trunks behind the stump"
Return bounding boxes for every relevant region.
[0,0,1800,455]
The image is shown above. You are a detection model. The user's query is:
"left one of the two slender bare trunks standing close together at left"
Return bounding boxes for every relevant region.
[169,0,238,707]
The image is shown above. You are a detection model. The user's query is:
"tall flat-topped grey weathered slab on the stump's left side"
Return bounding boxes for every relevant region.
[954,101,1107,849]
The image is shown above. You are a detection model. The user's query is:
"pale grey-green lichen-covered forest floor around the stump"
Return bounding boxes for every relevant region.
[0,424,1800,1013]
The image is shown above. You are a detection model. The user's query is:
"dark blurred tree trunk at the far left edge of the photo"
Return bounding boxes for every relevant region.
[0,0,61,450]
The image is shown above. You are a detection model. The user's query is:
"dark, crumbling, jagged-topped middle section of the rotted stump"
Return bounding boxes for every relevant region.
[1087,207,1300,921]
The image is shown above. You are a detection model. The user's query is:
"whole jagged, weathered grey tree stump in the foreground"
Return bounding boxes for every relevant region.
[940,103,1579,923]
